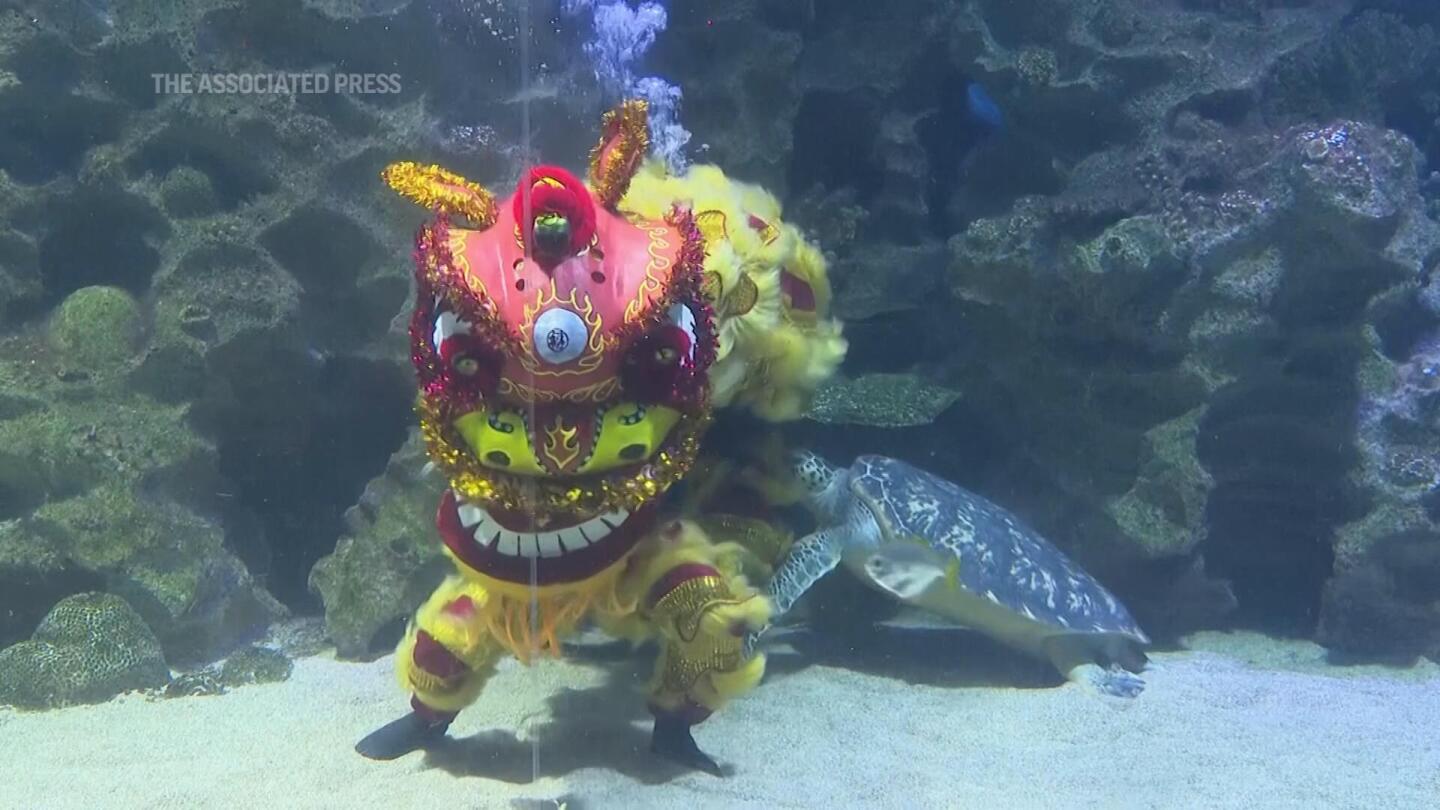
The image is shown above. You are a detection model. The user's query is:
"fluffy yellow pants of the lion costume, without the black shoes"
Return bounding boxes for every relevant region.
[396,520,770,722]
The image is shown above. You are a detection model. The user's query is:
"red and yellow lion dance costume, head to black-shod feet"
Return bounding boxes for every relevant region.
[357,101,845,773]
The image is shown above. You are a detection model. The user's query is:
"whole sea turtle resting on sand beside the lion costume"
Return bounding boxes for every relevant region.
[750,451,1149,698]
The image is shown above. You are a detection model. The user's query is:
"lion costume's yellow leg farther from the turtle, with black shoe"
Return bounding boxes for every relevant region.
[356,577,501,760]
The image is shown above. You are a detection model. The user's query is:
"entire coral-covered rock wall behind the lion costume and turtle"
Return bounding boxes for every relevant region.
[0,0,1440,660]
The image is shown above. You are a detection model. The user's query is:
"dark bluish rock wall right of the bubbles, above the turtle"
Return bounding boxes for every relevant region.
[661,0,1440,657]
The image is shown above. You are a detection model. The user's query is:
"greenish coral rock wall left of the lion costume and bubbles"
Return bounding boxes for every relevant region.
[0,0,596,664]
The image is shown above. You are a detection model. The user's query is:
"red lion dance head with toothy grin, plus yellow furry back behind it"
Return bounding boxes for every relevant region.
[384,102,844,585]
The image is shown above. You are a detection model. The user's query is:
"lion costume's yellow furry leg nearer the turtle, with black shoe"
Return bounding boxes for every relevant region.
[629,522,770,775]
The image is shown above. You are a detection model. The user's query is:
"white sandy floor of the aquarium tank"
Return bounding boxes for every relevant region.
[0,634,1440,810]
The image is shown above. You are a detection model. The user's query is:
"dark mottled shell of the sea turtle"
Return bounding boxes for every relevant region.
[850,455,1149,644]
